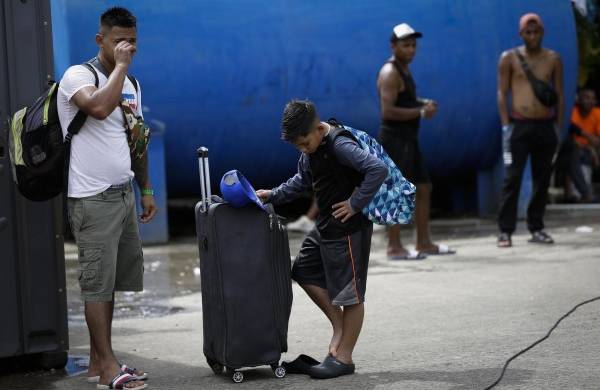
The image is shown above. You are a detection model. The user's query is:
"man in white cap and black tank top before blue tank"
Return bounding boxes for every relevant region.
[377,23,454,260]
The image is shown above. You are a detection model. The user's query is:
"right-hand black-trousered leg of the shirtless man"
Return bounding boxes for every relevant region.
[527,125,558,232]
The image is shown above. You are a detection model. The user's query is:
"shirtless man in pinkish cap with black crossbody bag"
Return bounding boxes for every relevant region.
[498,13,564,247]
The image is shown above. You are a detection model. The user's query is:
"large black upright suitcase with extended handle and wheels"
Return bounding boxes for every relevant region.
[196,148,292,383]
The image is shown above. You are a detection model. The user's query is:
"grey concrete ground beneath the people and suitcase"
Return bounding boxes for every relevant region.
[0,221,600,390]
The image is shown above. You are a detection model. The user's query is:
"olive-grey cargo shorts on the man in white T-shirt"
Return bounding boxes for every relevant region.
[68,182,144,302]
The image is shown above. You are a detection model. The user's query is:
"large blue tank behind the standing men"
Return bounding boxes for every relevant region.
[52,0,577,195]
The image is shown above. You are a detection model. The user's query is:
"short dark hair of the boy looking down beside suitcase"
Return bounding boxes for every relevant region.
[281,100,319,143]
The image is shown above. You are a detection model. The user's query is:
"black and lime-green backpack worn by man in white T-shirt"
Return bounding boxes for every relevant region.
[8,59,137,201]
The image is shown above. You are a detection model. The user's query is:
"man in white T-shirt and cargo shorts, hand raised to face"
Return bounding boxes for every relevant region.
[57,7,156,390]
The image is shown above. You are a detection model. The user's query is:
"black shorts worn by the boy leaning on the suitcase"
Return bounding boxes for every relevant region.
[292,223,373,306]
